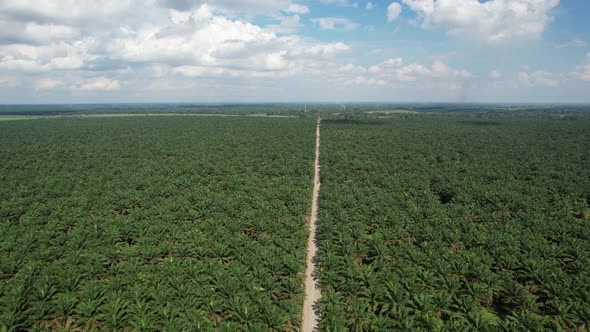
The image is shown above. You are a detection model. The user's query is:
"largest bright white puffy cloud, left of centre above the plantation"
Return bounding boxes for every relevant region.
[104,5,349,77]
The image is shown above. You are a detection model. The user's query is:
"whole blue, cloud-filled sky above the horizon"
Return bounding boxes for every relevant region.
[0,0,590,104]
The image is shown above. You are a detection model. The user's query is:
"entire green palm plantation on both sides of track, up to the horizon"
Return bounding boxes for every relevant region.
[0,104,590,331]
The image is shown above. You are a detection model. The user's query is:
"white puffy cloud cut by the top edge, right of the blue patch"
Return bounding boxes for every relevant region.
[402,0,559,44]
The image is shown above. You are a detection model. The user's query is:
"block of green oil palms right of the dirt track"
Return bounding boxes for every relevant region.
[318,113,590,331]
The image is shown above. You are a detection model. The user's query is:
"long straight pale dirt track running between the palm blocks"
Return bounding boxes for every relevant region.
[301,116,321,332]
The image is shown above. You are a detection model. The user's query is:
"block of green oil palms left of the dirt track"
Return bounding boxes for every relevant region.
[0,116,315,331]
